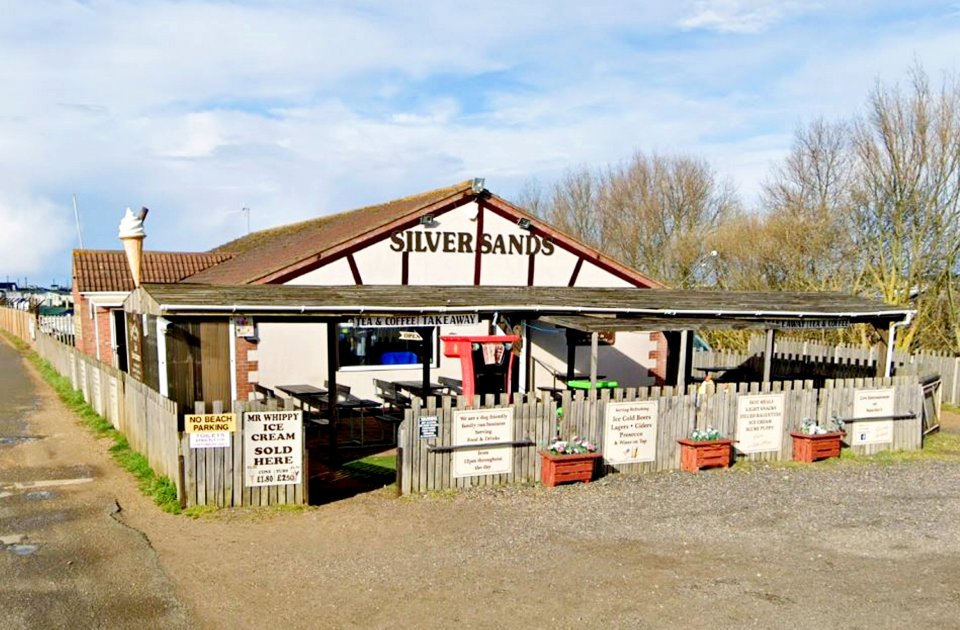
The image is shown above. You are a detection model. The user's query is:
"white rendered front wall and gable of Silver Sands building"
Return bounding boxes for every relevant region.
[257,203,656,398]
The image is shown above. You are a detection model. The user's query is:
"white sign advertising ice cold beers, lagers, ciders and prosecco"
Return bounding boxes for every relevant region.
[603,400,660,464]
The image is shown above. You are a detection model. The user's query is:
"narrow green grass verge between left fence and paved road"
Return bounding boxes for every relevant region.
[2,332,181,514]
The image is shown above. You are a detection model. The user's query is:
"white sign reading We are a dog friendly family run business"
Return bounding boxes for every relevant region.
[453,407,513,477]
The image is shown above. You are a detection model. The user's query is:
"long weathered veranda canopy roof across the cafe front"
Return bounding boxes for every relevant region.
[124,283,914,330]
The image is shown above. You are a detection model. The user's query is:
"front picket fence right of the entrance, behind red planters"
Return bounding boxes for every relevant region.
[398,376,923,494]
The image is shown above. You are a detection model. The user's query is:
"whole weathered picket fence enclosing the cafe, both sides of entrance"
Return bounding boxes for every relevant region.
[0,308,940,507]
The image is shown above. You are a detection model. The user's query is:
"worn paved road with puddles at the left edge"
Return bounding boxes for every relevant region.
[0,339,196,629]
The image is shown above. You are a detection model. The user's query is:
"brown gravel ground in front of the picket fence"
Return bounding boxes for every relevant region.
[127,460,960,628]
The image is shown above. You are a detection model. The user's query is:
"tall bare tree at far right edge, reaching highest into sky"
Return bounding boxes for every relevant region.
[850,68,960,348]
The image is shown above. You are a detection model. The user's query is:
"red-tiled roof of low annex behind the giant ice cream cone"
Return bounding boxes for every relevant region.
[73,249,230,292]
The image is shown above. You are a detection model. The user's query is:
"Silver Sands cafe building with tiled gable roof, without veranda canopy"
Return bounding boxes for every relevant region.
[148,179,668,412]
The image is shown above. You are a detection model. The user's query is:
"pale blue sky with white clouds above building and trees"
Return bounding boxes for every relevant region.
[0,0,960,285]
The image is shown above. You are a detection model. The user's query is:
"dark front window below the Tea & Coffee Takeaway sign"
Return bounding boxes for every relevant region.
[337,325,440,368]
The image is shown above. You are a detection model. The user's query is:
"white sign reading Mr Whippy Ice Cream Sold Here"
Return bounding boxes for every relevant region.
[243,411,303,487]
